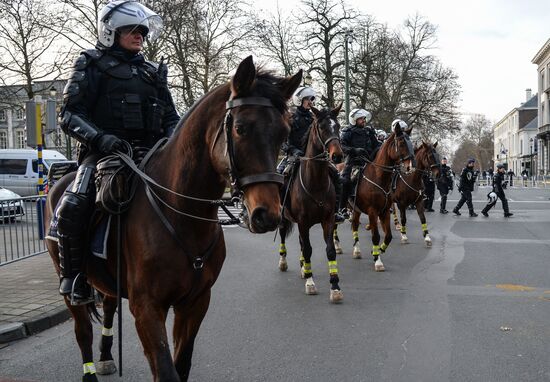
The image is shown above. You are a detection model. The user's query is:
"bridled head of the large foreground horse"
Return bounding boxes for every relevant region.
[213,56,302,233]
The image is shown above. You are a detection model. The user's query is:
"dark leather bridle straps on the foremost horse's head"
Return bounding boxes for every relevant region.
[224,97,284,191]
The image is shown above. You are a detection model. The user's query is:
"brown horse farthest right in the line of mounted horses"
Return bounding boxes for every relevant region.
[392,142,440,247]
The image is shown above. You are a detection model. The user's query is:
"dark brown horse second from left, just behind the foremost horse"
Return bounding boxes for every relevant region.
[279,104,343,303]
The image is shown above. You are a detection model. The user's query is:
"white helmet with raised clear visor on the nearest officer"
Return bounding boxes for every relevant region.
[97,0,162,48]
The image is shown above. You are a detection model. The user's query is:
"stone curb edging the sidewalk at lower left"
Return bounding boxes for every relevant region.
[0,306,71,344]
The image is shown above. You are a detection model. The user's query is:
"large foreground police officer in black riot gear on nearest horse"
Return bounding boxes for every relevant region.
[57,0,179,304]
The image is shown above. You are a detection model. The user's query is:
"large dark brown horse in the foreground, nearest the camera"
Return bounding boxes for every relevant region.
[45,57,302,381]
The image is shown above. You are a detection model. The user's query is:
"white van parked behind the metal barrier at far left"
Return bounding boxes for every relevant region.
[0,149,72,196]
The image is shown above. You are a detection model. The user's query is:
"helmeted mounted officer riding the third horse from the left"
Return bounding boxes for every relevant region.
[340,109,382,216]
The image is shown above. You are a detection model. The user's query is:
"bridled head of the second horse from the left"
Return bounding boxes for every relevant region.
[310,103,344,163]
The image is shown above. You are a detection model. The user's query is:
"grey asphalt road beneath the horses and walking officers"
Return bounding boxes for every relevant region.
[0,189,550,382]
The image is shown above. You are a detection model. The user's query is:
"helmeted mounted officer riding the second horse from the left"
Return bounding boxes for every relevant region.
[277,86,344,223]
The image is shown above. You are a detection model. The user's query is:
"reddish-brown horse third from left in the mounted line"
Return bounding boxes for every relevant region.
[334,125,415,272]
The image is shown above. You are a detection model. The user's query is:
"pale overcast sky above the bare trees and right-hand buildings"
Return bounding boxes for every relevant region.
[262,0,550,121]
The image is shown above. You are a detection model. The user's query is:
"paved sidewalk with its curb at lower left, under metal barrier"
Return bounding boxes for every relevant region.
[0,253,71,347]
